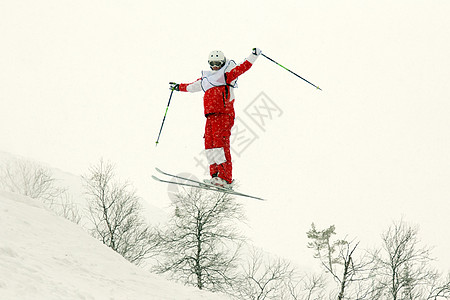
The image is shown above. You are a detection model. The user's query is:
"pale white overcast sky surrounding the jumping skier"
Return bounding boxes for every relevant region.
[0,0,450,270]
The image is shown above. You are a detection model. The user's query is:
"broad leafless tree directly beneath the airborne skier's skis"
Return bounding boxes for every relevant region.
[155,189,244,291]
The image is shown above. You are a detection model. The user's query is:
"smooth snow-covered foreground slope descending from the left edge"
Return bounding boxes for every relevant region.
[0,191,229,300]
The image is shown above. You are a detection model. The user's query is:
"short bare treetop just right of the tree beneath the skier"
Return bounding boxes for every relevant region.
[234,248,295,300]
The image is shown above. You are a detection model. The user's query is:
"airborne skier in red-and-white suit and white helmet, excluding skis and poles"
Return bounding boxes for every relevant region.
[169,48,261,189]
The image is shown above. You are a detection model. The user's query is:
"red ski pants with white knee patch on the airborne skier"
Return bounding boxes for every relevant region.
[205,114,234,183]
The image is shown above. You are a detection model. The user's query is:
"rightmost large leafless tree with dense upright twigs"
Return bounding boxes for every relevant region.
[377,220,450,300]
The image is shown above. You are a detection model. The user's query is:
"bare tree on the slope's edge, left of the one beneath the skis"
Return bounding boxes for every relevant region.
[83,160,157,264]
